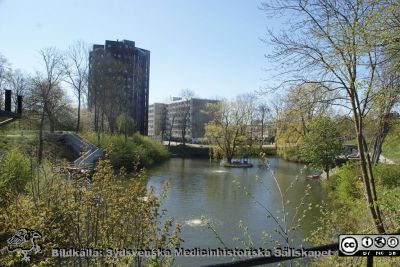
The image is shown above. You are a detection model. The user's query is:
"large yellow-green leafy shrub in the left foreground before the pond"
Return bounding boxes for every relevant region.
[0,160,180,266]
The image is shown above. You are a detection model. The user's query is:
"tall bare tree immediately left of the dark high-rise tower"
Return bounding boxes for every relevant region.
[63,41,89,132]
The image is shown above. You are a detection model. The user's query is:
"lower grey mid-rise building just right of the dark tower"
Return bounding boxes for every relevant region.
[148,97,218,143]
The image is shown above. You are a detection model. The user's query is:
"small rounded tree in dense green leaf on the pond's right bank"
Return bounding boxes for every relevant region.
[300,116,342,179]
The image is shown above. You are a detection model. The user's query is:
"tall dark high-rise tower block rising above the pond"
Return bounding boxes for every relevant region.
[88,40,150,135]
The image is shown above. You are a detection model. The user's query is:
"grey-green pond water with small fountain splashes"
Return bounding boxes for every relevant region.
[148,157,324,266]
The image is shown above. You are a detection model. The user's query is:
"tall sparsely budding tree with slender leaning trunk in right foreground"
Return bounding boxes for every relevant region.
[262,0,385,233]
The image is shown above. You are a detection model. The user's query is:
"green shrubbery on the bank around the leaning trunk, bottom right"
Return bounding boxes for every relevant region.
[310,163,400,266]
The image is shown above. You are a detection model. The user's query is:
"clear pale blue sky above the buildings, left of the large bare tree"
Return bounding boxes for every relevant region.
[0,0,272,103]
